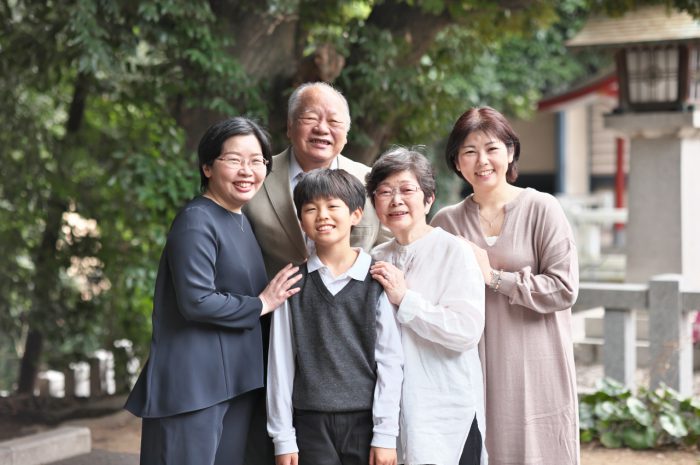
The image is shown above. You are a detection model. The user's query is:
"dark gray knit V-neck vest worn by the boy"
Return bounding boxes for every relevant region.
[289,264,383,412]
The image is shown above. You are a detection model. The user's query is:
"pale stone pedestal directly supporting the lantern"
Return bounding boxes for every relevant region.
[605,111,700,289]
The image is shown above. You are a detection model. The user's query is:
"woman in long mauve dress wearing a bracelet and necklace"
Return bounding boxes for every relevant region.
[432,107,580,465]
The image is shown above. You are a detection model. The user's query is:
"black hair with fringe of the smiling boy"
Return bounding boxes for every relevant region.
[294,168,365,219]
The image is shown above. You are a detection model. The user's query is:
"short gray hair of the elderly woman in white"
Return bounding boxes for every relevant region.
[365,147,435,205]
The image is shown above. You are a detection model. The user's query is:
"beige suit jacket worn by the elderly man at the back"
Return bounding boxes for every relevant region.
[243,149,389,278]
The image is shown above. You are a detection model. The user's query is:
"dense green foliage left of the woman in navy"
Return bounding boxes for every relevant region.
[0,0,238,365]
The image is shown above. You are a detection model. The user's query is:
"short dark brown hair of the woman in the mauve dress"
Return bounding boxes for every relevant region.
[445,107,520,183]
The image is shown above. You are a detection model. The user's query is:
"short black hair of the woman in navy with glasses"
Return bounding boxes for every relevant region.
[197,116,272,192]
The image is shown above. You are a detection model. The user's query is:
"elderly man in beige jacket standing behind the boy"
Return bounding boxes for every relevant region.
[244,82,389,465]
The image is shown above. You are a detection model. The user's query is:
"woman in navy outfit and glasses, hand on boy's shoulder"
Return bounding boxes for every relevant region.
[125,117,299,465]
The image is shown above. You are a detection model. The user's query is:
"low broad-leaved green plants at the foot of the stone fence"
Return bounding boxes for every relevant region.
[579,378,700,449]
